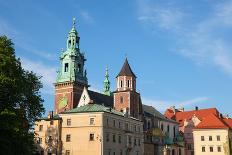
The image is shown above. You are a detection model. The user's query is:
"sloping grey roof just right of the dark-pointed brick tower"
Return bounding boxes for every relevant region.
[143,104,178,123]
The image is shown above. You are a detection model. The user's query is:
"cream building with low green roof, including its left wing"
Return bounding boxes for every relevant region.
[35,104,144,155]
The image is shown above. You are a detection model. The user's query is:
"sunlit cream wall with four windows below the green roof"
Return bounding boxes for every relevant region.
[60,113,103,155]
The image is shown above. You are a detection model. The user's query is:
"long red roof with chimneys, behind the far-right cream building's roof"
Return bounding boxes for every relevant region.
[164,108,220,126]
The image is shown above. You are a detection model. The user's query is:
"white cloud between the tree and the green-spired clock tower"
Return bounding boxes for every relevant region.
[21,58,56,95]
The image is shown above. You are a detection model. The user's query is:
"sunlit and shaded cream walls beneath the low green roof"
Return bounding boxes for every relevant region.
[60,112,144,155]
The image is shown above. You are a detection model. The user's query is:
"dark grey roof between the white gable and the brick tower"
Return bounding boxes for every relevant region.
[88,90,114,107]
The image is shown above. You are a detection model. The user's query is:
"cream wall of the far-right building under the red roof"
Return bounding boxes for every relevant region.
[193,129,229,155]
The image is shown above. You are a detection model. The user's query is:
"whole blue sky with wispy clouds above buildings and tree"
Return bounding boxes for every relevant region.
[0,0,232,116]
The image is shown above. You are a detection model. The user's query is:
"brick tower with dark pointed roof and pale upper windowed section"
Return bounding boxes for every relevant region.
[114,58,142,119]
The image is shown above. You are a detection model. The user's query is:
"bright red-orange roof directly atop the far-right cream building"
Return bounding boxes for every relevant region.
[196,113,229,129]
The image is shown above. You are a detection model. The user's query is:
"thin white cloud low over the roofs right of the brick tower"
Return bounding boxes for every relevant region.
[142,97,209,111]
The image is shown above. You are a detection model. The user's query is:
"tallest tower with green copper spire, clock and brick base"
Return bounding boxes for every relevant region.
[54,18,88,114]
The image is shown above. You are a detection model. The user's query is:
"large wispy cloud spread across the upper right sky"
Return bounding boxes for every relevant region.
[138,1,232,76]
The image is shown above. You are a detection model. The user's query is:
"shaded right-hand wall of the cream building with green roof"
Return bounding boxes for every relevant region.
[103,113,144,155]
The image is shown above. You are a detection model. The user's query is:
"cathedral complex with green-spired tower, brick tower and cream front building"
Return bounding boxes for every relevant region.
[35,19,183,155]
